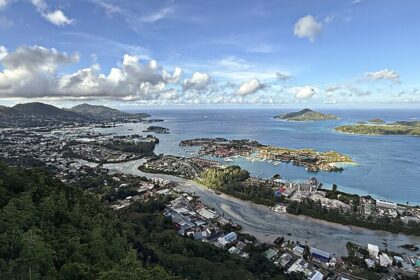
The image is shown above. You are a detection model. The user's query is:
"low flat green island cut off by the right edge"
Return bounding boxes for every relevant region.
[335,121,420,136]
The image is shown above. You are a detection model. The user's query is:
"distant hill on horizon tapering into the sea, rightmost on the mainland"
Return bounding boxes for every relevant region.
[70,103,150,121]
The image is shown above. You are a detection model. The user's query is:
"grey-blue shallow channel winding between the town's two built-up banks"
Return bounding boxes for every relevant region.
[104,159,420,256]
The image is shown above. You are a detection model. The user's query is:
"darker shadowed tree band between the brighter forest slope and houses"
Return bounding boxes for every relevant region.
[121,199,286,280]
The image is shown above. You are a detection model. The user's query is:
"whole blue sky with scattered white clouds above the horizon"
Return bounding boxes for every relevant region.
[0,0,420,108]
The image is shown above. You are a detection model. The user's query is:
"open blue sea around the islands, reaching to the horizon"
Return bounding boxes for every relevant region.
[126,108,420,204]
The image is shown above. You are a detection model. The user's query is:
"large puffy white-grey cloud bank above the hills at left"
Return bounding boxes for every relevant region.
[0,46,182,100]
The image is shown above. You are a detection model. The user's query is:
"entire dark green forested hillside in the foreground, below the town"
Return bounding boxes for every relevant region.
[0,162,302,280]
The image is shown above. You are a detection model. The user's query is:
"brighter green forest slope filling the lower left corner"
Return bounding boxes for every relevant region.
[0,163,176,279]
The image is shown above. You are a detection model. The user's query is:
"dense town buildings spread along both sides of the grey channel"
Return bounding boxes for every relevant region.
[0,121,420,280]
